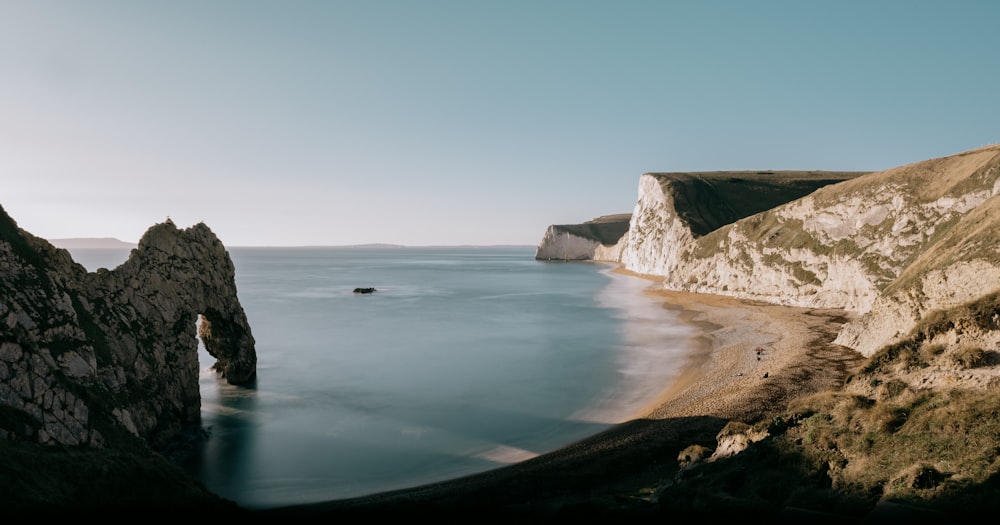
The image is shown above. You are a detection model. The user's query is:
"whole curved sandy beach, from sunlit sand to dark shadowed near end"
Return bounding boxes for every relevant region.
[260,270,863,522]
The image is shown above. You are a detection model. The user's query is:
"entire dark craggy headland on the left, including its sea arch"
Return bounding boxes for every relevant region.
[0,208,256,448]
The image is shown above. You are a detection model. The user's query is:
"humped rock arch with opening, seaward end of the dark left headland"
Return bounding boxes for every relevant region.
[88,219,257,444]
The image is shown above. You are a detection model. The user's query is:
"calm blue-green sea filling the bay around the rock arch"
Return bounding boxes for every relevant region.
[64,245,692,509]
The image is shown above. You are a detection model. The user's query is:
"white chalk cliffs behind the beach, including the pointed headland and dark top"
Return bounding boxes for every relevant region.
[552,141,1000,355]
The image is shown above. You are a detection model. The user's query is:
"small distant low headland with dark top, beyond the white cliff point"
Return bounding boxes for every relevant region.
[535,213,632,261]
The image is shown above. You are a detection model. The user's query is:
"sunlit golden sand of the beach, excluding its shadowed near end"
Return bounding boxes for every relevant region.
[616,269,864,422]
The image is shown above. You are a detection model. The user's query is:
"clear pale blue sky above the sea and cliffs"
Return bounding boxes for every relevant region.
[0,0,1000,246]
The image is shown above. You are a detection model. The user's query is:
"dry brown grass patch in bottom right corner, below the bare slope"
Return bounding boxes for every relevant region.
[659,382,1000,517]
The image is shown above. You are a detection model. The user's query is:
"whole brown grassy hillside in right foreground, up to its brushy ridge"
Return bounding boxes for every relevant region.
[659,295,1000,521]
